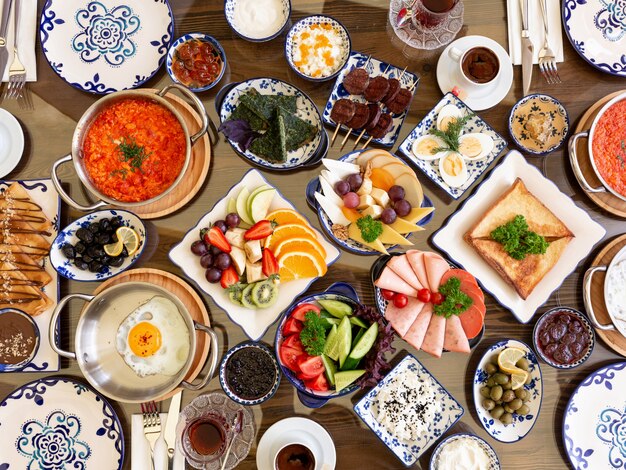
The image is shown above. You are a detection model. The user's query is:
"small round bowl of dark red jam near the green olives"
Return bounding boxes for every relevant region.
[533,307,596,369]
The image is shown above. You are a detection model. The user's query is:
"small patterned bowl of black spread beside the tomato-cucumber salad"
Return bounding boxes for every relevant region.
[219,341,281,406]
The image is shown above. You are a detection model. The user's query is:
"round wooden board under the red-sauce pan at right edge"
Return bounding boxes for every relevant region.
[575,90,626,218]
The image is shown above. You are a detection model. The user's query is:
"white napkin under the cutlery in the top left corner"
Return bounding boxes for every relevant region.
[2,0,37,82]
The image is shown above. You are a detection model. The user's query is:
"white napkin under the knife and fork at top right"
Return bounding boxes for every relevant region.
[506,0,563,65]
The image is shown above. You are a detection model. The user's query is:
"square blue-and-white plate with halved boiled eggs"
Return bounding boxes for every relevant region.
[399,93,506,199]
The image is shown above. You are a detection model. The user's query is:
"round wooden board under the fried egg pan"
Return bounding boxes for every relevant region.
[90,268,211,401]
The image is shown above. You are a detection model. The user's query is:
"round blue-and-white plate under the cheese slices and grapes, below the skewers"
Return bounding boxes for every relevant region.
[306,150,435,256]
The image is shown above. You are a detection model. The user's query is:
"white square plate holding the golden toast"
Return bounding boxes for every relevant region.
[433,150,606,323]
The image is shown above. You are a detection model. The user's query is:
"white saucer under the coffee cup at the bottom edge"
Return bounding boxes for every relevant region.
[256,418,337,470]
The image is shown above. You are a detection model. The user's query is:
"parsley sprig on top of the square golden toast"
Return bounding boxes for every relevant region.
[491,215,550,260]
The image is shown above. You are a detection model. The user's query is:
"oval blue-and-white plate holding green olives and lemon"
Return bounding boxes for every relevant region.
[472,339,543,444]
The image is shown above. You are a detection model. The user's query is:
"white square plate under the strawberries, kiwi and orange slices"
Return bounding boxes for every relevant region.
[169,170,340,341]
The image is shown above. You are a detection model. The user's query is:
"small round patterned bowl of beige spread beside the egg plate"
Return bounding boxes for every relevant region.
[509,94,569,155]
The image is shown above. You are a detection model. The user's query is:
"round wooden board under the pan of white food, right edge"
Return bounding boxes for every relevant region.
[590,234,626,357]
